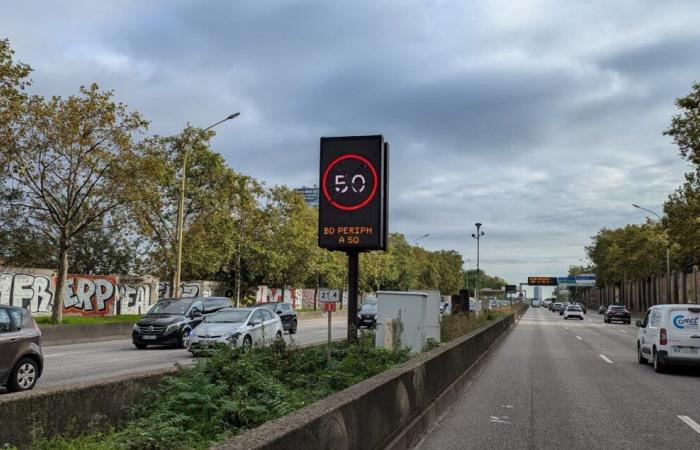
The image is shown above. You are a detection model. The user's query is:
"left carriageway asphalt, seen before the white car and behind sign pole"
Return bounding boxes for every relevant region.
[34,318,347,390]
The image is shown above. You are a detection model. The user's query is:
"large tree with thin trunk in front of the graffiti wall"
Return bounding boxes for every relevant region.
[0,84,147,323]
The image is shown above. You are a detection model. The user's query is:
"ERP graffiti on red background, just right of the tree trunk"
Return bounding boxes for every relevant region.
[63,275,117,316]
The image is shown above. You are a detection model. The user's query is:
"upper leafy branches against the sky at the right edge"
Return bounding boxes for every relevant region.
[664,83,700,170]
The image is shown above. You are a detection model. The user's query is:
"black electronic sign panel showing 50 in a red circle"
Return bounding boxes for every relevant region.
[318,136,388,250]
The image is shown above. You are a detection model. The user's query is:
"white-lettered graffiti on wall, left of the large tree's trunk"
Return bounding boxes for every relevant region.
[0,268,56,313]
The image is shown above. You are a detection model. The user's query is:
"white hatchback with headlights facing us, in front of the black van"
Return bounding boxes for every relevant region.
[186,307,284,356]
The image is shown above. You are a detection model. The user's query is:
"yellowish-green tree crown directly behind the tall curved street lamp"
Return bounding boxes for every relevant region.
[129,127,261,285]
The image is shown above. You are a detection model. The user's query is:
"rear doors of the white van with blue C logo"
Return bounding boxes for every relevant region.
[667,305,700,359]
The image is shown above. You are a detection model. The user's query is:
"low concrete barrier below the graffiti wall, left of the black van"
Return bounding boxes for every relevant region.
[39,322,134,347]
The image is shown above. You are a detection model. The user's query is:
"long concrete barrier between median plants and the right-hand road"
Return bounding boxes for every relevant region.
[214,306,527,450]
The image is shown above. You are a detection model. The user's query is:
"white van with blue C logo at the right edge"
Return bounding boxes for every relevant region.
[637,305,700,372]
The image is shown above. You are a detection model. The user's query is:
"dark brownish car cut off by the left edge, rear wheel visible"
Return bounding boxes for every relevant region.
[0,306,44,392]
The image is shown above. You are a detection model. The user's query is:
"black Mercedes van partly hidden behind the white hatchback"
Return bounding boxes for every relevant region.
[131,297,233,349]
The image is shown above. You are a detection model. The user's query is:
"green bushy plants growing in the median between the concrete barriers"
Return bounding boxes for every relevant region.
[34,340,409,450]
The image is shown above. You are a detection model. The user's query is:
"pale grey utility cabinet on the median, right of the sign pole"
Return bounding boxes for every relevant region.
[375,291,441,353]
